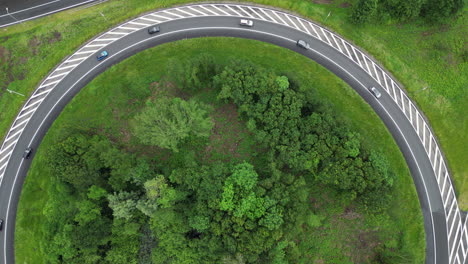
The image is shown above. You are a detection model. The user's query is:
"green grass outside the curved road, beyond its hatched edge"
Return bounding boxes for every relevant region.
[0,0,468,209]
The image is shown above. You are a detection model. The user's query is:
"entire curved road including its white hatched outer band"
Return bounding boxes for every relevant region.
[0,4,462,264]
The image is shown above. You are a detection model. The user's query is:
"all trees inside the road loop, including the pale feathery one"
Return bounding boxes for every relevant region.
[43,55,404,263]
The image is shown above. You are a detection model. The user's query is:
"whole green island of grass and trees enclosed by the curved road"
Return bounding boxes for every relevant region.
[15,38,425,263]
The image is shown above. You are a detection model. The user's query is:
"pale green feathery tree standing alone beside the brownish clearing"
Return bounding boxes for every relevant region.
[134,97,213,152]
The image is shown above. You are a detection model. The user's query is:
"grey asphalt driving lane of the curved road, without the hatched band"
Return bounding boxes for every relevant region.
[0,14,449,264]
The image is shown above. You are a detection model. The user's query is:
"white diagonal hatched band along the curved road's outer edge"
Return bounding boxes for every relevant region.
[0,4,460,263]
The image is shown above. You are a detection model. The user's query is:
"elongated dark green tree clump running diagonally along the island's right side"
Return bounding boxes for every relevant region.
[214,60,394,207]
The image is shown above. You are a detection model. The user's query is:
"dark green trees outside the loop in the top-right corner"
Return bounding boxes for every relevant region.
[351,0,464,23]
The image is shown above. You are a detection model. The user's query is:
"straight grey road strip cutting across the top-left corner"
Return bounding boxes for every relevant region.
[0,0,98,28]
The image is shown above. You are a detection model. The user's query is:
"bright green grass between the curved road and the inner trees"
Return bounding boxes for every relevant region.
[16,38,425,263]
